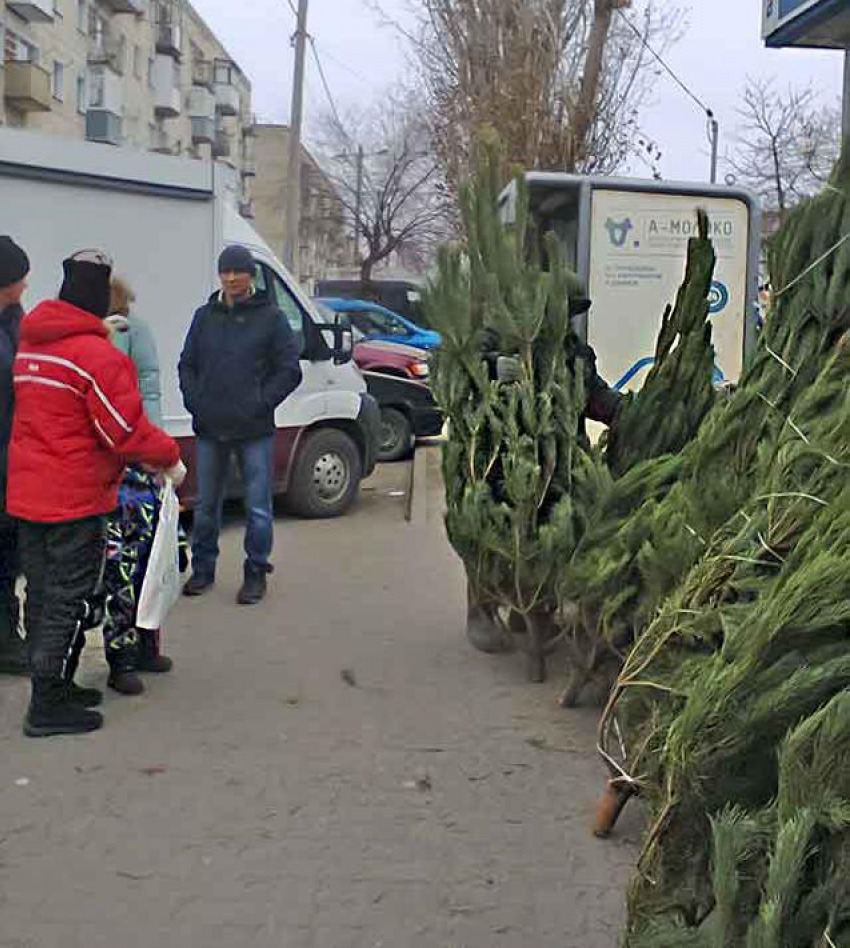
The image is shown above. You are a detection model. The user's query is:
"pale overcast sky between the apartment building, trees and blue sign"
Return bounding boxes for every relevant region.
[192,0,843,179]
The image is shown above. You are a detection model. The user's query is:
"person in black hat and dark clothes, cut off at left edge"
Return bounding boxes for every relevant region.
[0,237,30,675]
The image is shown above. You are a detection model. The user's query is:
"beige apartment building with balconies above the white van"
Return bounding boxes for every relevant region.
[0,0,256,217]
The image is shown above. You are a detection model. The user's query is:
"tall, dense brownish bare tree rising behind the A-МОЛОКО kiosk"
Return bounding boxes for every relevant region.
[372,0,681,193]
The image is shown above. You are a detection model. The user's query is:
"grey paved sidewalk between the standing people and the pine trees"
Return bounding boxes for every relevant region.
[0,455,634,948]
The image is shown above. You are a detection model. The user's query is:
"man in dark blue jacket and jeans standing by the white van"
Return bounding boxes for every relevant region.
[179,246,301,605]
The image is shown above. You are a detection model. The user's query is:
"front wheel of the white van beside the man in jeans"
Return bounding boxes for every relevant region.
[286,428,363,520]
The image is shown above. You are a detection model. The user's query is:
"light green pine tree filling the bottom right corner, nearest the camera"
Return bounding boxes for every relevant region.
[629,691,850,948]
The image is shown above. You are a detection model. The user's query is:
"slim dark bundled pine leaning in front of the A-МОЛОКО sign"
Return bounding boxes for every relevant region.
[559,211,717,706]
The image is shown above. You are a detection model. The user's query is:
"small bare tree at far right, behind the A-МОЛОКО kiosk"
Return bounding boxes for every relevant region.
[727,79,841,217]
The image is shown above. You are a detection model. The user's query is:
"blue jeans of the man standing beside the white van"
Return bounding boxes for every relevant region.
[192,436,274,578]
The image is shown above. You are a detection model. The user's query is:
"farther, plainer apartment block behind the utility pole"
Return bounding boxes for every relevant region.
[253,124,353,286]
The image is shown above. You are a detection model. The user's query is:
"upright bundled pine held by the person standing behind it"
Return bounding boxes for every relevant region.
[424,146,600,680]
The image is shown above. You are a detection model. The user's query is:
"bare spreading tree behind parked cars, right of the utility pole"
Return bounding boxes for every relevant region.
[319,94,451,283]
